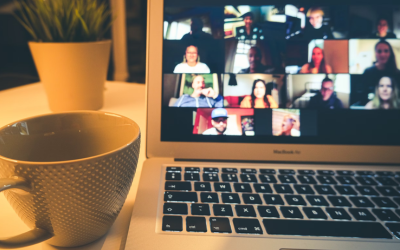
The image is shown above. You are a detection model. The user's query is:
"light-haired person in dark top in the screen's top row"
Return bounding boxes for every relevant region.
[300,7,334,40]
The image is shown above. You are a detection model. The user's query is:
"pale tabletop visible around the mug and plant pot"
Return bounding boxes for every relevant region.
[0,82,146,250]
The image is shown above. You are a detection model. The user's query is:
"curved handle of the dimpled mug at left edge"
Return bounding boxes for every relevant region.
[0,177,53,248]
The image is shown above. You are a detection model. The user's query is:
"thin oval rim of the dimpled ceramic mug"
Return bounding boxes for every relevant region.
[0,110,140,165]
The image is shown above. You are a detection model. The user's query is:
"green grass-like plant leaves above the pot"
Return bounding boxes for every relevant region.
[14,0,112,42]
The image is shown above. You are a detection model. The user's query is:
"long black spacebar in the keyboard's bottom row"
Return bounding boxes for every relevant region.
[263,219,392,239]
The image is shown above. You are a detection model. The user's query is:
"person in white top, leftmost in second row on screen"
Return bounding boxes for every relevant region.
[174,45,210,74]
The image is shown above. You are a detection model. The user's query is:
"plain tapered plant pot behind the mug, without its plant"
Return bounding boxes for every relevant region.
[29,40,111,112]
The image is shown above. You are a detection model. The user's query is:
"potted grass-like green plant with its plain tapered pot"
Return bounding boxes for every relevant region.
[15,0,112,112]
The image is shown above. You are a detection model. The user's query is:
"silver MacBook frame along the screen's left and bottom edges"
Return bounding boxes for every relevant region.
[146,0,400,164]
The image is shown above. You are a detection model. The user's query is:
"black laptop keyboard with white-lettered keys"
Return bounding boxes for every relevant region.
[161,166,400,239]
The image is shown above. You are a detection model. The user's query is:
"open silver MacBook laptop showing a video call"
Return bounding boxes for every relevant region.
[126,0,400,250]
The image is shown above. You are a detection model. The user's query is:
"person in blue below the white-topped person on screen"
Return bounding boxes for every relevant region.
[174,75,224,108]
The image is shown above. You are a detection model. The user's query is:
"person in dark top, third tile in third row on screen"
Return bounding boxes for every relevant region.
[308,78,343,109]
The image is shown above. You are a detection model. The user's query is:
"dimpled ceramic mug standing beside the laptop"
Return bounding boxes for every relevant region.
[0,111,140,248]
